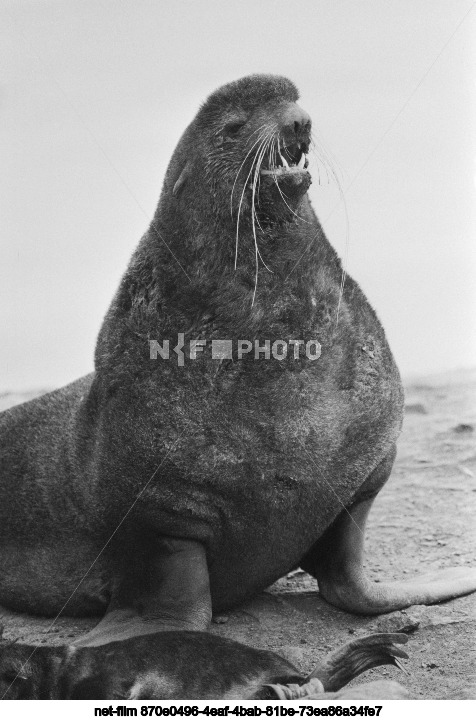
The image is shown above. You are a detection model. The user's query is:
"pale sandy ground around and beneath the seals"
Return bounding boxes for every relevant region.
[0,370,476,699]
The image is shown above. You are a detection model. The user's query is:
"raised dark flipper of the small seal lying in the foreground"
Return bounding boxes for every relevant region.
[307,633,408,691]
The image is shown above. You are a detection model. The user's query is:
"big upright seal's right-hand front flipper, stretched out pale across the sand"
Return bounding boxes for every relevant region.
[300,453,476,615]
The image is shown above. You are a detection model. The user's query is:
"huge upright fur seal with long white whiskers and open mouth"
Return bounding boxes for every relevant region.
[0,75,476,645]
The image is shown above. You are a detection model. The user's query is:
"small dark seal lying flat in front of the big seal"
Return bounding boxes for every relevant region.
[0,631,408,700]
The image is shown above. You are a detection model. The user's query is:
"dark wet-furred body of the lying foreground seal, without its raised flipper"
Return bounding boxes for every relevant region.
[0,632,304,699]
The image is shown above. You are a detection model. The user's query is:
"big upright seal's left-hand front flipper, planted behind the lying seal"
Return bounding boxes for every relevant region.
[75,538,212,646]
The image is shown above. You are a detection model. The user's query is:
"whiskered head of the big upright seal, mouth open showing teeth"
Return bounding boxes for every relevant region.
[166,75,311,224]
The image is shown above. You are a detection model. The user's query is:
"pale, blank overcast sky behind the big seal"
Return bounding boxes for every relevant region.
[0,0,476,391]
